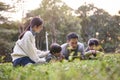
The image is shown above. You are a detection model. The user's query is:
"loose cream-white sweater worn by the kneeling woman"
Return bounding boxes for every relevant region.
[11,31,48,63]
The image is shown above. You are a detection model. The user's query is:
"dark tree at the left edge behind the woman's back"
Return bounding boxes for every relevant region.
[0,2,18,63]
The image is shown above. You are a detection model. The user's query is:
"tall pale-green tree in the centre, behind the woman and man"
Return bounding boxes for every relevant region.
[27,0,81,50]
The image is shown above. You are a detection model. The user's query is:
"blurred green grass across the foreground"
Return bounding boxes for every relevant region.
[0,54,120,80]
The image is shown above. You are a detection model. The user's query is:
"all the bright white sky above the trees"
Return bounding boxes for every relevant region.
[1,0,120,21]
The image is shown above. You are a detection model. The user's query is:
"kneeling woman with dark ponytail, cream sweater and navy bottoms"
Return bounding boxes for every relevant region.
[11,17,49,66]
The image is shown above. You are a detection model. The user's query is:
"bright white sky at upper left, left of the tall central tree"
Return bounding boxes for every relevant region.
[1,0,42,22]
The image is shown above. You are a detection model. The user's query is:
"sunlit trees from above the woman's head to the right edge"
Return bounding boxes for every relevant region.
[26,0,120,52]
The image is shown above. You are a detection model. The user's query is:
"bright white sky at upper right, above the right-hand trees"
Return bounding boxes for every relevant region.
[62,0,120,15]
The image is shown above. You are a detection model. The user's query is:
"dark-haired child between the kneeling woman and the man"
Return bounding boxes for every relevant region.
[46,43,64,62]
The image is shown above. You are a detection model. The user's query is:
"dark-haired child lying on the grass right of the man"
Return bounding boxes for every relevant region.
[85,38,104,59]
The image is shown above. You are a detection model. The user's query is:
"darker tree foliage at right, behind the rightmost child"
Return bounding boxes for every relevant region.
[76,4,120,52]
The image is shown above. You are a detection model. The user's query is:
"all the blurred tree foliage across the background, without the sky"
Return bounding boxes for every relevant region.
[0,0,120,62]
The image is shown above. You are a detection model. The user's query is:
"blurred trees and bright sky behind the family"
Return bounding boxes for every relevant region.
[0,0,120,62]
